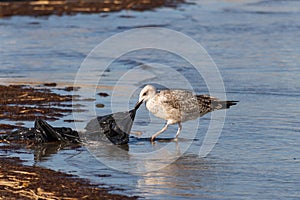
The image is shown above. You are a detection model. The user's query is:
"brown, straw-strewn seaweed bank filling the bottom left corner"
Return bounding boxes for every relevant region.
[0,157,137,199]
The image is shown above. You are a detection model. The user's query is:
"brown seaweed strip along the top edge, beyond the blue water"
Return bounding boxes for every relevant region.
[0,0,183,17]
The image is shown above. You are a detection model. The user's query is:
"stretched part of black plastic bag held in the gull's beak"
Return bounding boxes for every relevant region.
[85,102,142,145]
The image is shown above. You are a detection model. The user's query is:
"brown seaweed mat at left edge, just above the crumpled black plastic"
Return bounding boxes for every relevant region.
[0,85,82,133]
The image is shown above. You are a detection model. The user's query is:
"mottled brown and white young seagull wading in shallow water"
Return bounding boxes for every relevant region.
[137,85,238,142]
